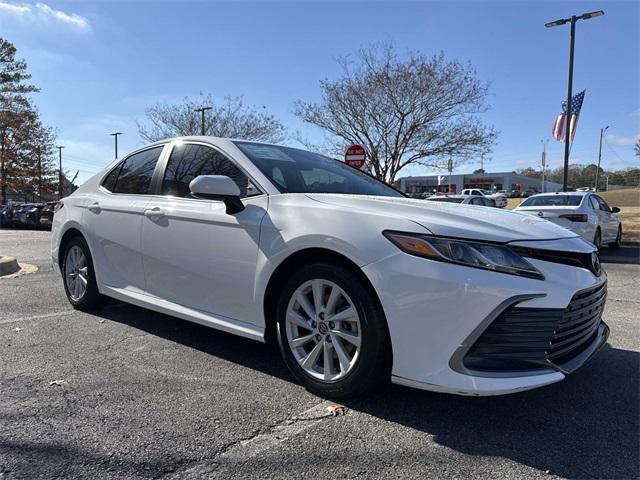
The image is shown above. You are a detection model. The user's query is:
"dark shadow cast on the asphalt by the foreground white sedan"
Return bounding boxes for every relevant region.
[98,306,640,478]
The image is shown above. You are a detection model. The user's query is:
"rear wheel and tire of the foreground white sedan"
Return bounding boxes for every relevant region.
[61,236,107,311]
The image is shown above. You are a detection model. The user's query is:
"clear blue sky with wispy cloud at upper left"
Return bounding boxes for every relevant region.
[0,0,640,184]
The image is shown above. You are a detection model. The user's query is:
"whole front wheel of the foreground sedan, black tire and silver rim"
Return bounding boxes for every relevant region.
[277,263,391,399]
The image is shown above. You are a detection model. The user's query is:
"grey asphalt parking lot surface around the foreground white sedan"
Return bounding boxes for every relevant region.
[0,230,640,479]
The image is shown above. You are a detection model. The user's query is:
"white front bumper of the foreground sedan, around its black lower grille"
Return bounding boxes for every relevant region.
[363,246,608,395]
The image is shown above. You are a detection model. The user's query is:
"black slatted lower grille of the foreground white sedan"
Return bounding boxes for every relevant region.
[464,283,607,371]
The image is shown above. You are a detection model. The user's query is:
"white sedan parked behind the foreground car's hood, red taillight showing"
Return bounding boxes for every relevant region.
[514,191,622,249]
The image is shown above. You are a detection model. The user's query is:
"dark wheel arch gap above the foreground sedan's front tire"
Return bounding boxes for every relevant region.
[262,247,390,343]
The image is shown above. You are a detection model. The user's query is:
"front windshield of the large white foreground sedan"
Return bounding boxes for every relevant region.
[234,142,404,197]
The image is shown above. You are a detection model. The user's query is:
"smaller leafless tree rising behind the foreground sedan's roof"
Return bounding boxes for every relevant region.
[138,94,286,143]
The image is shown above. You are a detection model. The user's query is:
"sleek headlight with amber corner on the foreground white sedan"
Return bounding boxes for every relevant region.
[382,231,544,280]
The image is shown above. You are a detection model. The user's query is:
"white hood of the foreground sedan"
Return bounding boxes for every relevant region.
[307,193,577,243]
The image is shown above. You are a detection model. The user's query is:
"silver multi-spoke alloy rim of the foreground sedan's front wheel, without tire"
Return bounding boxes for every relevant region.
[285,279,362,382]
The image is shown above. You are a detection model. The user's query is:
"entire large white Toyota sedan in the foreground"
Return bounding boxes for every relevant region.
[52,137,608,398]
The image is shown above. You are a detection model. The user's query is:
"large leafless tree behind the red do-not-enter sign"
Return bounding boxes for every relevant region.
[295,44,496,183]
